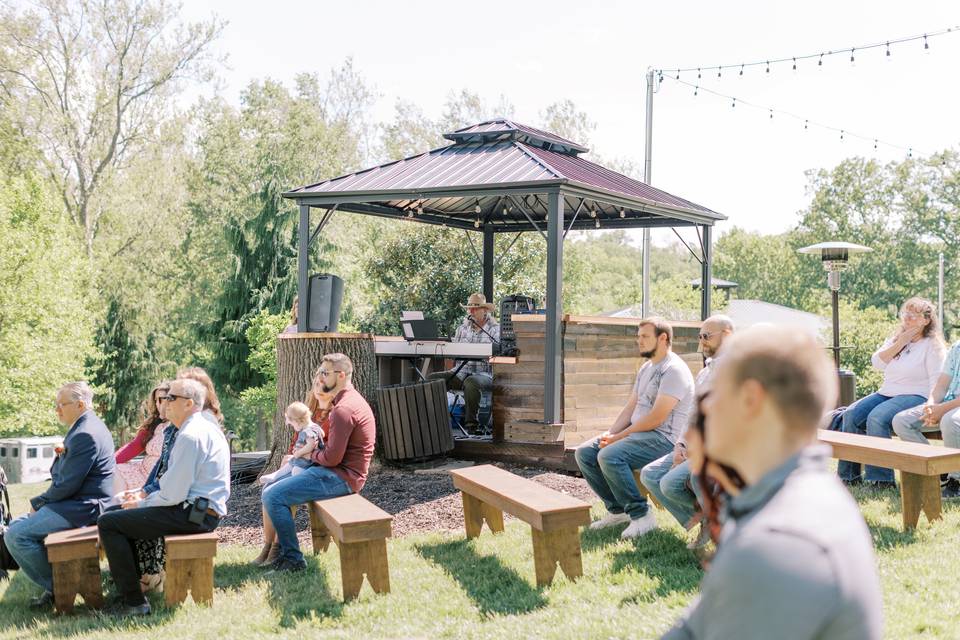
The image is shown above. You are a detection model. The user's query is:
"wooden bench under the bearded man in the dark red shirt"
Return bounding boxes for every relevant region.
[308,493,393,601]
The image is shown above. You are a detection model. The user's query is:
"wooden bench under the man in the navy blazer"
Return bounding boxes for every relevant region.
[44,525,103,613]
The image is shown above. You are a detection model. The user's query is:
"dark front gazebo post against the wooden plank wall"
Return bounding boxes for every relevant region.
[543,191,563,424]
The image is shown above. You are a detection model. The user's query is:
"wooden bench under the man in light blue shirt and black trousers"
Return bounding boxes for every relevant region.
[163,531,217,606]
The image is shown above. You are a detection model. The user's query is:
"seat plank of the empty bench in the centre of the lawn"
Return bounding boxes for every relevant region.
[450,464,590,531]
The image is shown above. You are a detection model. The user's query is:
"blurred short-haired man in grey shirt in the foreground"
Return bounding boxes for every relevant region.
[663,327,883,640]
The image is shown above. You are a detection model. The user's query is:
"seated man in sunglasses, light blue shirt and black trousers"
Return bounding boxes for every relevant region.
[97,378,230,616]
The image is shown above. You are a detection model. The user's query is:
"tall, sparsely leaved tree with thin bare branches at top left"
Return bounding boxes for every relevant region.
[0,0,223,255]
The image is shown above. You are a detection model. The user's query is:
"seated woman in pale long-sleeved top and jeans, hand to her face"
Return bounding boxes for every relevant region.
[837,297,946,487]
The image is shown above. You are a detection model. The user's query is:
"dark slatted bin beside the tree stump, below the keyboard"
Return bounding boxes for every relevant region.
[377,380,453,462]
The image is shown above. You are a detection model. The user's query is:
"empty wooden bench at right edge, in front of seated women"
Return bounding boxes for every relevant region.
[818,429,960,530]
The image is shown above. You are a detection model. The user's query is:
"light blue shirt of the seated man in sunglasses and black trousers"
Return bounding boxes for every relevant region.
[140,413,230,516]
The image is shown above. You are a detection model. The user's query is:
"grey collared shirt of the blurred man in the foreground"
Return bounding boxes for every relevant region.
[663,445,883,640]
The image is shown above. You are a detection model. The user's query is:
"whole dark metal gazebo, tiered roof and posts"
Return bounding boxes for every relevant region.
[283,118,726,423]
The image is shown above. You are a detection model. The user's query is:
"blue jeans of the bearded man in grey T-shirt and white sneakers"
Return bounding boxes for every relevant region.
[574,431,673,520]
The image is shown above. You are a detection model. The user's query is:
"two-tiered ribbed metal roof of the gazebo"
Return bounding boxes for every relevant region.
[283,118,726,233]
